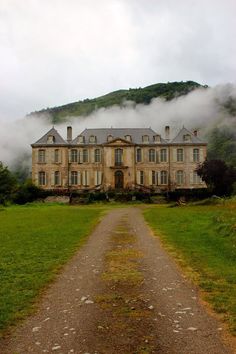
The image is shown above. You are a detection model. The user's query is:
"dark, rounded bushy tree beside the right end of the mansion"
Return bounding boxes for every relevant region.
[197,160,236,195]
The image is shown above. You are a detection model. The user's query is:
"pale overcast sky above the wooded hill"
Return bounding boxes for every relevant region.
[0,0,236,120]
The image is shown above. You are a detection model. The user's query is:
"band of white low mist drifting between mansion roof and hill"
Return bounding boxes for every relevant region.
[0,84,236,168]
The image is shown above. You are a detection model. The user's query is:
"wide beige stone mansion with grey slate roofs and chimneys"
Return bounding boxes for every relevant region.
[32,127,207,191]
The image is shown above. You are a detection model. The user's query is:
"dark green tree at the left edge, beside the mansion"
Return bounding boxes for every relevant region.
[0,161,17,205]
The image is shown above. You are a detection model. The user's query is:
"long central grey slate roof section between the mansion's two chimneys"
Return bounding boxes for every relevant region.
[72,128,167,144]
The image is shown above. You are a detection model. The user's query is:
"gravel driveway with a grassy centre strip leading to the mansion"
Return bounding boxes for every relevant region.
[0,208,233,354]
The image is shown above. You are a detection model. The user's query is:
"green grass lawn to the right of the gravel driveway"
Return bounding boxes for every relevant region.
[144,201,236,335]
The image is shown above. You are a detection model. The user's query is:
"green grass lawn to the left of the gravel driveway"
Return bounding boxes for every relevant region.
[0,205,104,333]
